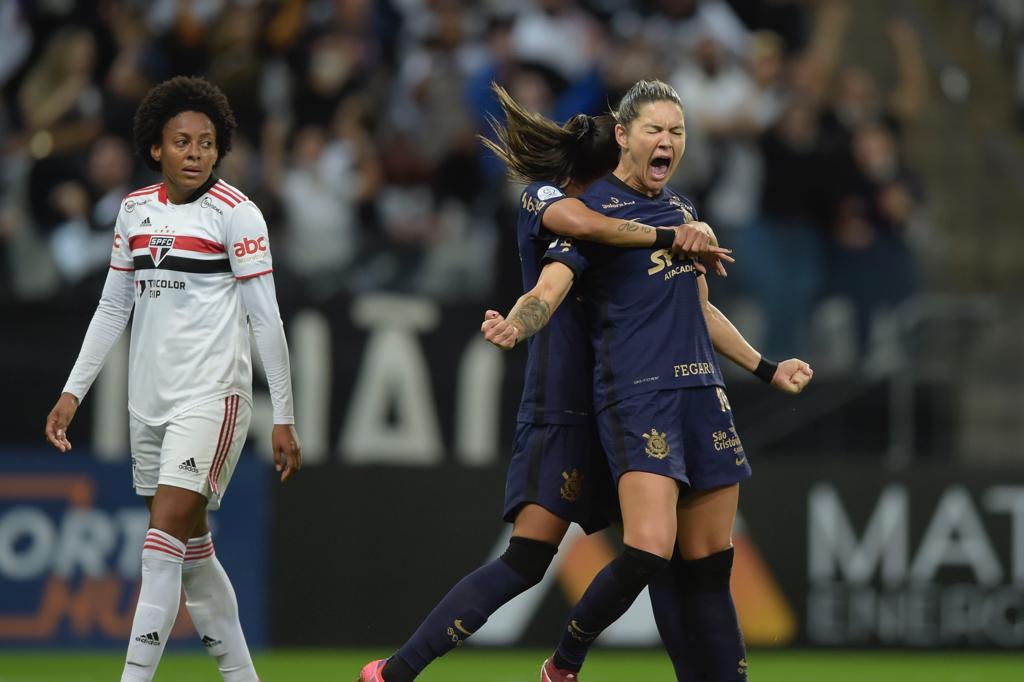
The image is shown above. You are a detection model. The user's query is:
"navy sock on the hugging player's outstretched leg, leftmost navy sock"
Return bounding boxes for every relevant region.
[381,538,558,682]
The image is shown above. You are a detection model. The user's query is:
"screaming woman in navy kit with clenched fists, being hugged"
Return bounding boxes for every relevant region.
[488,76,812,682]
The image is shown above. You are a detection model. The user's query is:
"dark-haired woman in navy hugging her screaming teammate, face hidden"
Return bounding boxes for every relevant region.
[359,86,731,682]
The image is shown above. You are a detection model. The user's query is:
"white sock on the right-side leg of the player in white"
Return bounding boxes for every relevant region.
[181,534,259,682]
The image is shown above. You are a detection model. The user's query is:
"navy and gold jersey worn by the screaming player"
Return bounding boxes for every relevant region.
[545,173,725,411]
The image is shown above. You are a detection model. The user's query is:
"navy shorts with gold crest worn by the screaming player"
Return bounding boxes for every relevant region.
[597,386,751,491]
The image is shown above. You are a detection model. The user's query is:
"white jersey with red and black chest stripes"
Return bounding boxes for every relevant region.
[77,176,292,425]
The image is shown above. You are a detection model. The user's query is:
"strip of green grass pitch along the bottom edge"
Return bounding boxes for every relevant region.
[0,649,1024,682]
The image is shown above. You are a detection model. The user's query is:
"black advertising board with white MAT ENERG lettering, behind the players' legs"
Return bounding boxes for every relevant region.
[269,456,1024,649]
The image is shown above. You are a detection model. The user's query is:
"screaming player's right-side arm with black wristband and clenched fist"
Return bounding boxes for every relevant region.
[697,278,814,393]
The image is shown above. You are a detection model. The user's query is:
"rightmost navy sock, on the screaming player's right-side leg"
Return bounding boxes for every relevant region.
[681,547,746,682]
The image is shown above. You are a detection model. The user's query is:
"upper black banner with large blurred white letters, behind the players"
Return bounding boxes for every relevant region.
[0,294,956,456]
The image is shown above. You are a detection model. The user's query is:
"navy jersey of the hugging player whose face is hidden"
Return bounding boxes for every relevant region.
[516,182,594,424]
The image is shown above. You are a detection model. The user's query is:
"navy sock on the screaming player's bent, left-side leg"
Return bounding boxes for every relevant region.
[554,545,669,672]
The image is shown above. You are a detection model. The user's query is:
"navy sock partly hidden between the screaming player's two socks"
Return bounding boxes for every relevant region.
[647,547,700,682]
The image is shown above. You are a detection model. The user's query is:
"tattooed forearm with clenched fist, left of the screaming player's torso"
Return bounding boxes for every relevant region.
[480,261,573,350]
